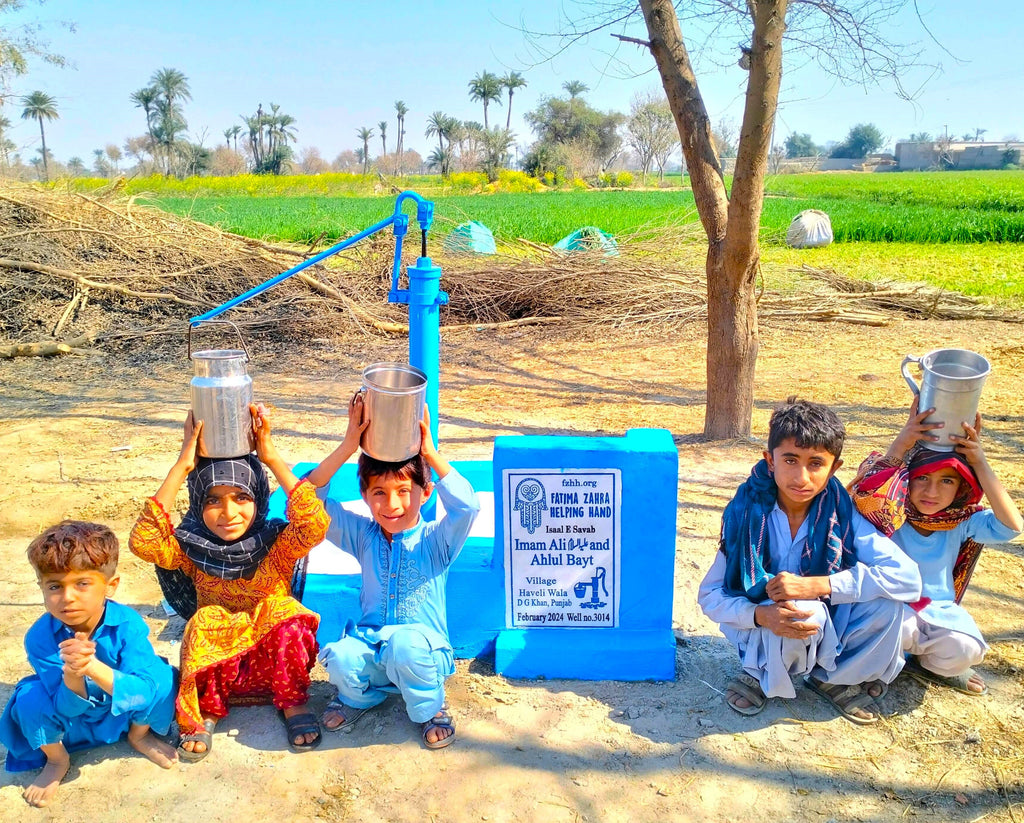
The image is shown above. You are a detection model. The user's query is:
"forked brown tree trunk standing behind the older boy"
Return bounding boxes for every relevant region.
[640,0,786,439]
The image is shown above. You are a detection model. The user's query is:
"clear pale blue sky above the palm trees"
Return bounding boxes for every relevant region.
[0,0,1024,164]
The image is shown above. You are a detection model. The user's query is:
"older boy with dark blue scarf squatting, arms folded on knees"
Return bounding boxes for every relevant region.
[697,400,921,724]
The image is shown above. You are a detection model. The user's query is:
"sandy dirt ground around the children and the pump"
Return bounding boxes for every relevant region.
[0,320,1024,823]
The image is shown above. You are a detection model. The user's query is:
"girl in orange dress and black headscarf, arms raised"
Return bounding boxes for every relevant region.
[129,405,330,762]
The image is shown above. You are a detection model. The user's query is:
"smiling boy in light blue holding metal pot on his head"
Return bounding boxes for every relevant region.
[309,395,479,748]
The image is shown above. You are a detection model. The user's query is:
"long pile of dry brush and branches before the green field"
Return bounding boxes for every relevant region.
[0,182,1010,357]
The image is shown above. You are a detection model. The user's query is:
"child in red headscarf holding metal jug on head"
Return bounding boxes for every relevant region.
[851,400,1024,695]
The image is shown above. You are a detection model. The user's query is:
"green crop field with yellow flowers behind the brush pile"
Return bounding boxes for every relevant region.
[78,170,1024,304]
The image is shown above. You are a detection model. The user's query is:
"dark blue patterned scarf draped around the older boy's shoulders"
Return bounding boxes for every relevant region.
[719,460,857,603]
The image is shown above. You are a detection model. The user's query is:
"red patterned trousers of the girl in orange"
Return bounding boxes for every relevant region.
[196,618,317,718]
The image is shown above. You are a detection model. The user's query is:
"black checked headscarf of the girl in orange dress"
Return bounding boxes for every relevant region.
[174,454,288,580]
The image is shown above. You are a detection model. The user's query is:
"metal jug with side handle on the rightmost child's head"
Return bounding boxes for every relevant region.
[900,349,991,451]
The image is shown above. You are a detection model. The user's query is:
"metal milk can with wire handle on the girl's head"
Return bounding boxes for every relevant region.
[188,320,256,458]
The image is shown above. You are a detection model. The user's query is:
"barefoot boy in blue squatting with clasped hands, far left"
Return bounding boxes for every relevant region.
[0,520,176,807]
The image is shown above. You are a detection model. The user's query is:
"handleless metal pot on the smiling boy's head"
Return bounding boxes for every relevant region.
[359,362,427,463]
